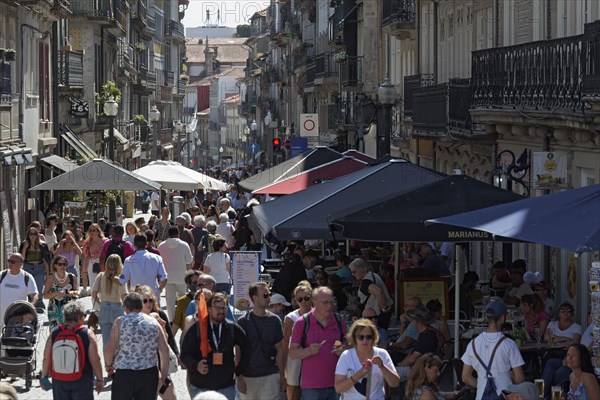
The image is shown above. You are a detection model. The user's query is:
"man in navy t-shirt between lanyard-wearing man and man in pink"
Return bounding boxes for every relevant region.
[237,282,286,400]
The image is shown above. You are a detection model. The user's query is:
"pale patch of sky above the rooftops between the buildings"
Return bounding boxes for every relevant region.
[182,0,270,28]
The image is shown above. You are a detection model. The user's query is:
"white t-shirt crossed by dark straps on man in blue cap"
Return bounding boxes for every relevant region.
[461,332,525,400]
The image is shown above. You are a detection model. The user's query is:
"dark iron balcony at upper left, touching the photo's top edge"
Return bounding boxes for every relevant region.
[71,0,128,37]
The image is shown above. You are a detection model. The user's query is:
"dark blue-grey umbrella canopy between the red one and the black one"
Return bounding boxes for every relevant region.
[252,160,444,240]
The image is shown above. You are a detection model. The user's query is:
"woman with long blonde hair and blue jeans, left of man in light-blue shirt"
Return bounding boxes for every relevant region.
[92,254,127,348]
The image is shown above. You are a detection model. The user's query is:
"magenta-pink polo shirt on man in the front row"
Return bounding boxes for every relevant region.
[290,309,346,389]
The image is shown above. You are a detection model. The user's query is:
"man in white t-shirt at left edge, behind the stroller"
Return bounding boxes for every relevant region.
[0,253,38,332]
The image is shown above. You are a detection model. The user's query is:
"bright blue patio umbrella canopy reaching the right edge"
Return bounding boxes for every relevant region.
[427,184,600,253]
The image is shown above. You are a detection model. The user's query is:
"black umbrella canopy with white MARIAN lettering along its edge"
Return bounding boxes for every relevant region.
[332,175,523,242]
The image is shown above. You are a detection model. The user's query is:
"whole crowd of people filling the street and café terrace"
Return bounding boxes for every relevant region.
[0,186,600,400]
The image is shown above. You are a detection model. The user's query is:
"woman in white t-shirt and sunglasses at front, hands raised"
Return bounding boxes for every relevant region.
[335,318,400,400]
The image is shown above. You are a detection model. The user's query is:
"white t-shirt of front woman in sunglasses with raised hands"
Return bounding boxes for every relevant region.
[335,347,395,400]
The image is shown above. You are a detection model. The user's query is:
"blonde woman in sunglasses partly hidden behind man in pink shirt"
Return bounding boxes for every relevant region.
[281,281,312,400]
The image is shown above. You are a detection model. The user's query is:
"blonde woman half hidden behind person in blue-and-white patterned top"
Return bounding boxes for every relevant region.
[134,285,179,400]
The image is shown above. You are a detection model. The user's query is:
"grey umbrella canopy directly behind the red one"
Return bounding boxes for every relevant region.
[239,146,344,192]
